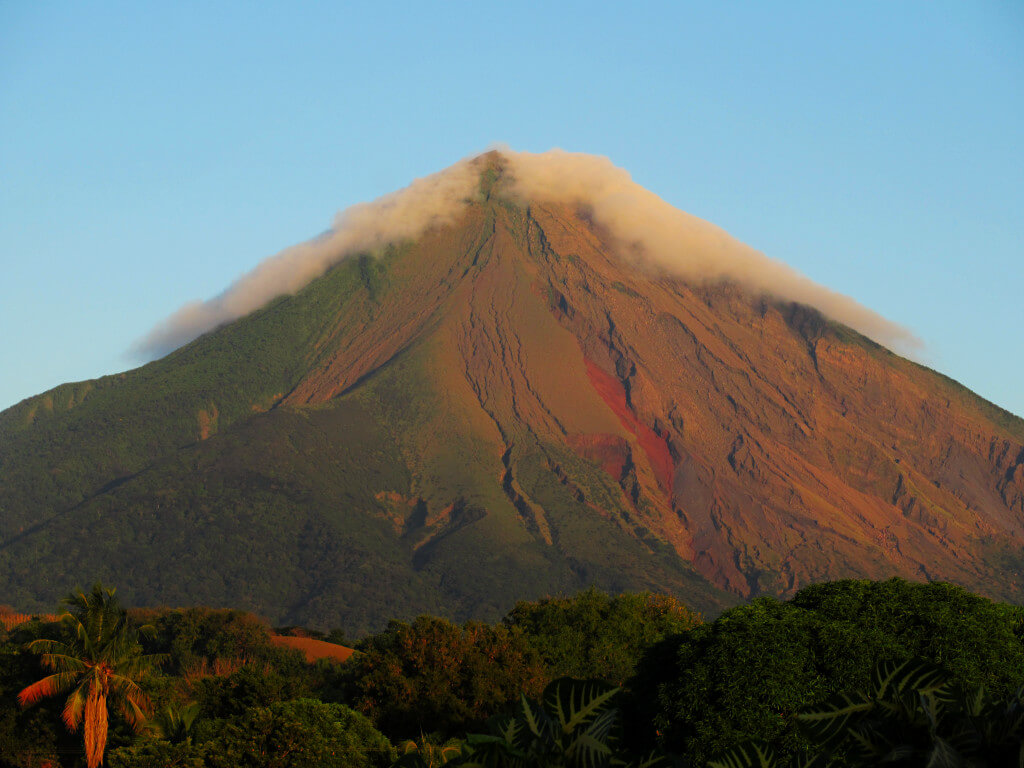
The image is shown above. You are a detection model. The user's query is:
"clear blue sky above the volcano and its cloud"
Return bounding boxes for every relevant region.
[0,0,1024,415]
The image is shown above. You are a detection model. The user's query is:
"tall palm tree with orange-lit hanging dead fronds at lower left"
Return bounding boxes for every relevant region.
[17,583,162,768]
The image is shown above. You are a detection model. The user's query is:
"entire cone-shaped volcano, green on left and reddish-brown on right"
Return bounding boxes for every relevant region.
[0,169,1024,633]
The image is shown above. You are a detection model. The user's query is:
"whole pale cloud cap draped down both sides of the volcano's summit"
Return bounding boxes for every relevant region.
[132,148,921,358]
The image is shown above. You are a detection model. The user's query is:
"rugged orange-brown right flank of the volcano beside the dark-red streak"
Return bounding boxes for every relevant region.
[520,201,1024,597]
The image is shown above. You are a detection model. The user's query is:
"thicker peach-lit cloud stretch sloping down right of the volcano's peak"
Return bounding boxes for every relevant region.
[502,150,922,352]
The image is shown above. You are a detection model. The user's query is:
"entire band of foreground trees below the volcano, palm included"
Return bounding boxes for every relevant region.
[0,579,1024,768]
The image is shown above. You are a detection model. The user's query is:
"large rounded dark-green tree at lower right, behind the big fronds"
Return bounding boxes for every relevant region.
[630,579,1024,765]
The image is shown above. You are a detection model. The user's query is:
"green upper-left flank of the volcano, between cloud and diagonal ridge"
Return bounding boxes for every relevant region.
[0,250,393,542]
